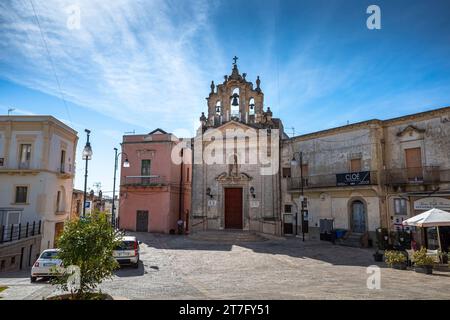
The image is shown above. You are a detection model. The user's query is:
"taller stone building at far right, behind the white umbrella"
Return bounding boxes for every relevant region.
[381,107,450,249]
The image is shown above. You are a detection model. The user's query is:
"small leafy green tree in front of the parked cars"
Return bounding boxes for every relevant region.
[52,212,121,299]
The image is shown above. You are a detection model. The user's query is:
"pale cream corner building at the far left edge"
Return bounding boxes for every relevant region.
[0,116,78,249]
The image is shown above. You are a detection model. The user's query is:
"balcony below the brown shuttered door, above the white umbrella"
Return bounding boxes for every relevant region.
[385,166,442,185]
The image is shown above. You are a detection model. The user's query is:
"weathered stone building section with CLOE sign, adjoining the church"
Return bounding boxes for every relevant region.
[281,120,383,245]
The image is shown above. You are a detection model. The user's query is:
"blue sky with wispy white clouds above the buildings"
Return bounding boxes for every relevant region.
[0,0,450,195]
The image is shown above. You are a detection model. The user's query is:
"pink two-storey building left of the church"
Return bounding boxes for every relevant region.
[119,129,192,233]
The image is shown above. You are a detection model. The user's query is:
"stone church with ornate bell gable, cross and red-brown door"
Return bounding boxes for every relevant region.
[191,60,286,234]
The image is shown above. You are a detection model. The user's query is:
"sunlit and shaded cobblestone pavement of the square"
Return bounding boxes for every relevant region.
[0,233,450,299]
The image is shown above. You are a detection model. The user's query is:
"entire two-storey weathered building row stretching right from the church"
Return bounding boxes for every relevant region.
[281,107,450,246]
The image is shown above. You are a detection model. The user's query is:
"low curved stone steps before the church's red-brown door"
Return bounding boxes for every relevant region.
[189,230,267,243]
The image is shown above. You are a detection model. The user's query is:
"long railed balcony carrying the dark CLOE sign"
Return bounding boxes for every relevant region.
[287,171,378,191]
